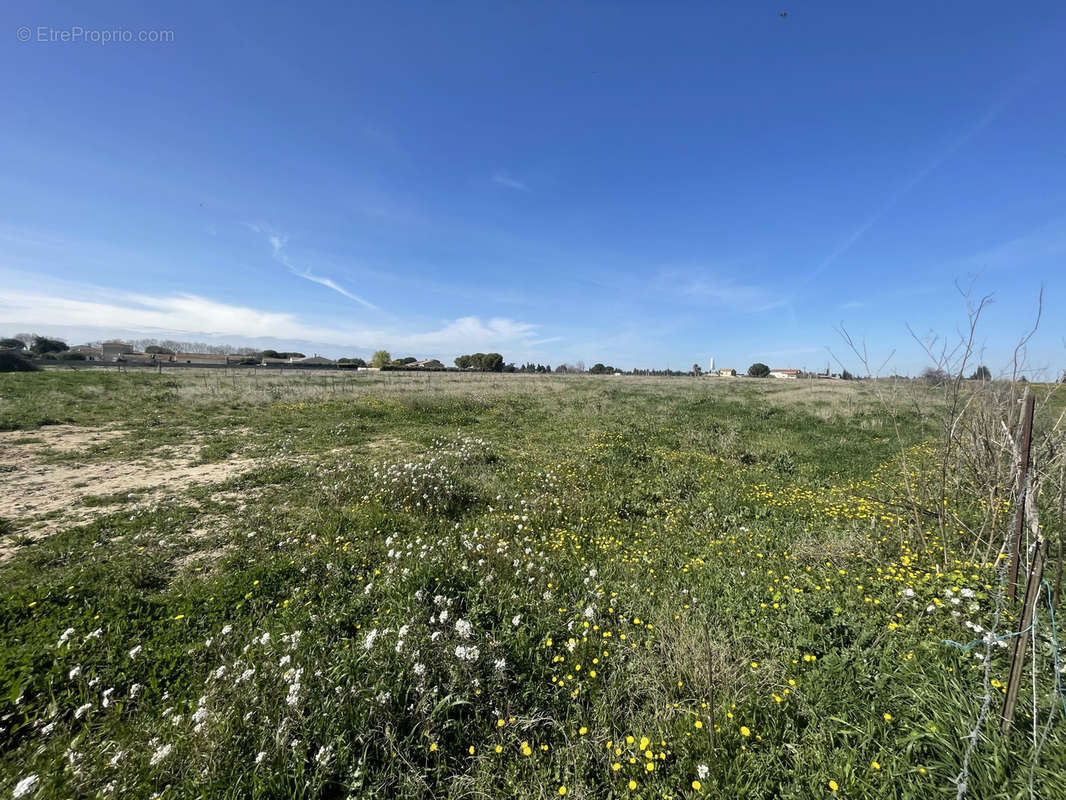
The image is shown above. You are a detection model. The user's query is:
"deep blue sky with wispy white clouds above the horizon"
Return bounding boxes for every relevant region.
[0,0,1066,373]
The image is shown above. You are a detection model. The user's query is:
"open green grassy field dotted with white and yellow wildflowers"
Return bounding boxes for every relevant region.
[0,370,1066,798]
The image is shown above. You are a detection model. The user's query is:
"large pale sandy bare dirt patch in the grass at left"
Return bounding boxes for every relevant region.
[0,426,261,561]
